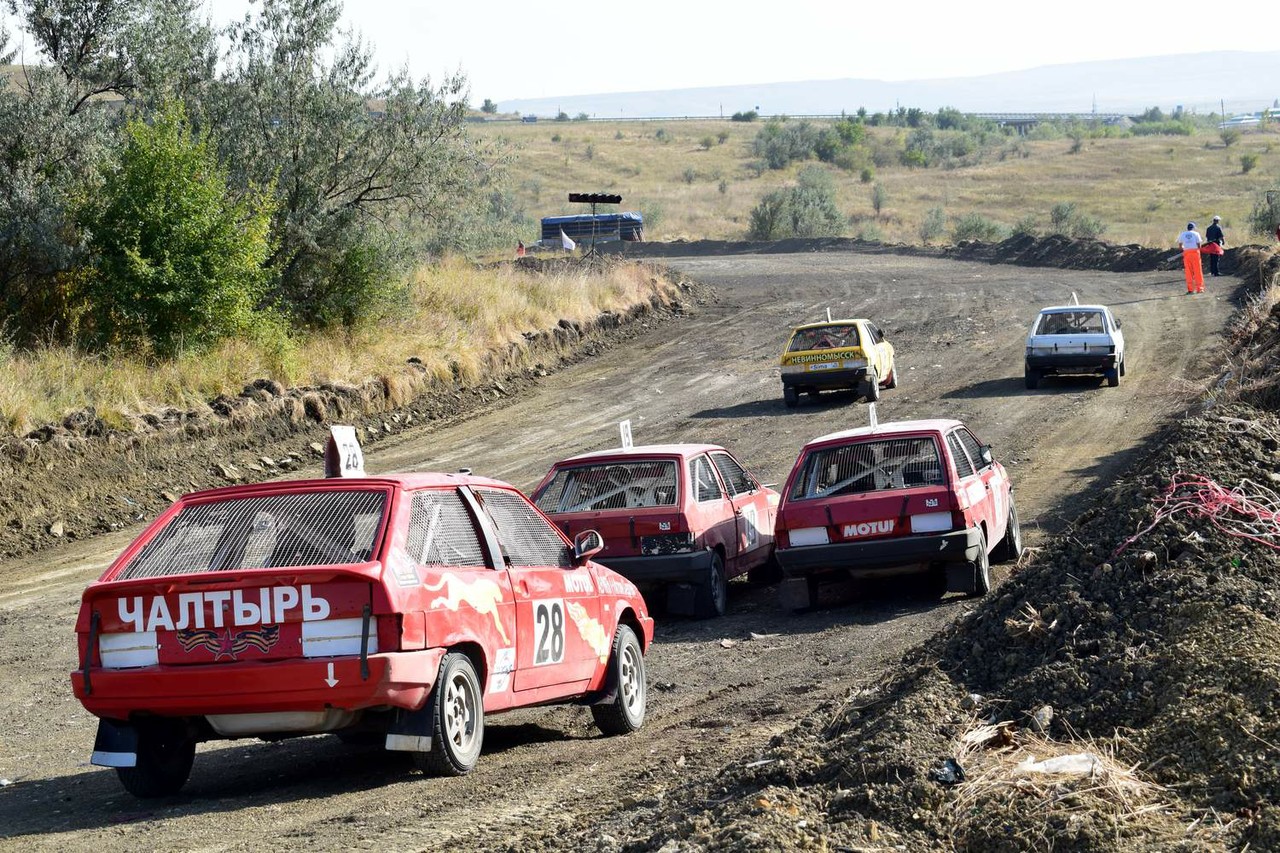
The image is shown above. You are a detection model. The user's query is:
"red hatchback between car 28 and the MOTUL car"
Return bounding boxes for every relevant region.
[532,444,778,617]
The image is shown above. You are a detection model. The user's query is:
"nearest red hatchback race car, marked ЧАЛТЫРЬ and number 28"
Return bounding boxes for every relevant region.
[72,455,653,797]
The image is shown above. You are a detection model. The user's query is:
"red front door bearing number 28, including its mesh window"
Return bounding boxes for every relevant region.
[475,487,613,694]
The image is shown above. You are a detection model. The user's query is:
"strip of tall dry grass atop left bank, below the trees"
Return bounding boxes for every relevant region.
[0,260,669,435]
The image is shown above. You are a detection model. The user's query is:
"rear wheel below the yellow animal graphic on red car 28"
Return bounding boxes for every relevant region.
[413,652,484,776]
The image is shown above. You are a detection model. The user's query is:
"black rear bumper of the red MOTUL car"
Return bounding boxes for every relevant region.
[774,528,979,578]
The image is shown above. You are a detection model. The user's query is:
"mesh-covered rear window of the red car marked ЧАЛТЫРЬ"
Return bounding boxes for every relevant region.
[119,489,387,580]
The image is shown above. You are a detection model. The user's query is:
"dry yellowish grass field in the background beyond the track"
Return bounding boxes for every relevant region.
[474,120,1280,246]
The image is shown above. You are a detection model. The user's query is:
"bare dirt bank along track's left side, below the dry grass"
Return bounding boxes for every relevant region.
[0,259,710,557]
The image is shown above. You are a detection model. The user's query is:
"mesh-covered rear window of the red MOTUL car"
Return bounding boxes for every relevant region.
[791,438,945,501]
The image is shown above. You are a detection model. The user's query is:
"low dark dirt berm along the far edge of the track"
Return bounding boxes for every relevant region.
[604,234,1223,273]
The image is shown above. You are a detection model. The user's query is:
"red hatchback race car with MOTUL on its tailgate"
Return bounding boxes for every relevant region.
[776,420,1023,610]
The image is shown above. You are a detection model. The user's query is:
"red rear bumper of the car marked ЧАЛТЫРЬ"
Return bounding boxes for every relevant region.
[72,648,444,720]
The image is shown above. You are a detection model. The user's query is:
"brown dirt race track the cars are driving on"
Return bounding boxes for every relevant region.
[0,252,1236,853]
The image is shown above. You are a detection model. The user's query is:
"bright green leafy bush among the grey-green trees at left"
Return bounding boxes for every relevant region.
[81,102,274,356]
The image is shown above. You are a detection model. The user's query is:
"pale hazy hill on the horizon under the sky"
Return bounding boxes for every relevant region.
[499,51,1280,118]
